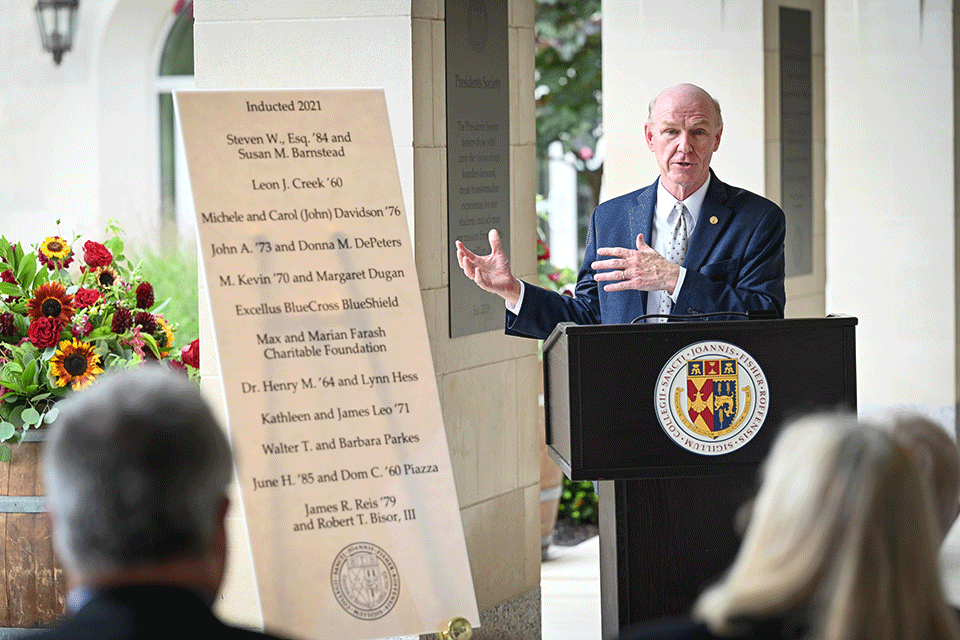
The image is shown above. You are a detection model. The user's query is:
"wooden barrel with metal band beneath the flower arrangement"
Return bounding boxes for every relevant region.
[0,429,66,638]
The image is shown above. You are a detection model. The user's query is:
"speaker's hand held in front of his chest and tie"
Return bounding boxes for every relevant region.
[590,233,680,295]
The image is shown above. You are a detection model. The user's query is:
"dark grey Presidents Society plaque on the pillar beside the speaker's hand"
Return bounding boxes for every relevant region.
[446,0,512,338]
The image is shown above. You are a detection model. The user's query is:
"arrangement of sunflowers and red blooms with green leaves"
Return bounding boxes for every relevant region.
[0,222,200,462]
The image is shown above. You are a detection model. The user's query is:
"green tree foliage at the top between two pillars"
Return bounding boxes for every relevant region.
[535,0,603,160]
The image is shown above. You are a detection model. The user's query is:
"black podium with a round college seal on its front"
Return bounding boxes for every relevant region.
[543,316,857,638]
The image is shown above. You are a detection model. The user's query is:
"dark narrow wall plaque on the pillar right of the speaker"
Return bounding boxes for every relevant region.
[780,7,813,277]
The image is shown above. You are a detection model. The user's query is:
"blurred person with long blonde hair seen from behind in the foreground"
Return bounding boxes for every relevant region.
[624,415,960,640]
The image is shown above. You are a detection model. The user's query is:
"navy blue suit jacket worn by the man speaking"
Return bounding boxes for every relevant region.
[506,169,786,339]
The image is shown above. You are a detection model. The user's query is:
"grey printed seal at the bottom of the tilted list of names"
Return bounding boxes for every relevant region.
[330,542,400,620]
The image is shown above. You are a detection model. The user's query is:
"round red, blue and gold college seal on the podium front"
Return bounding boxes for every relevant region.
[655,340,770,456]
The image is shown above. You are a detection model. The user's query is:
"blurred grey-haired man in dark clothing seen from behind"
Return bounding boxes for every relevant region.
[41,366,288,640]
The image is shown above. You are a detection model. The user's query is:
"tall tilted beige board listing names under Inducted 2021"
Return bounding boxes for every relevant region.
[176,89,479,640]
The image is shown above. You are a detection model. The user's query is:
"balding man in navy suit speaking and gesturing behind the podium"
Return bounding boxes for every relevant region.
[457,84,786,339]
